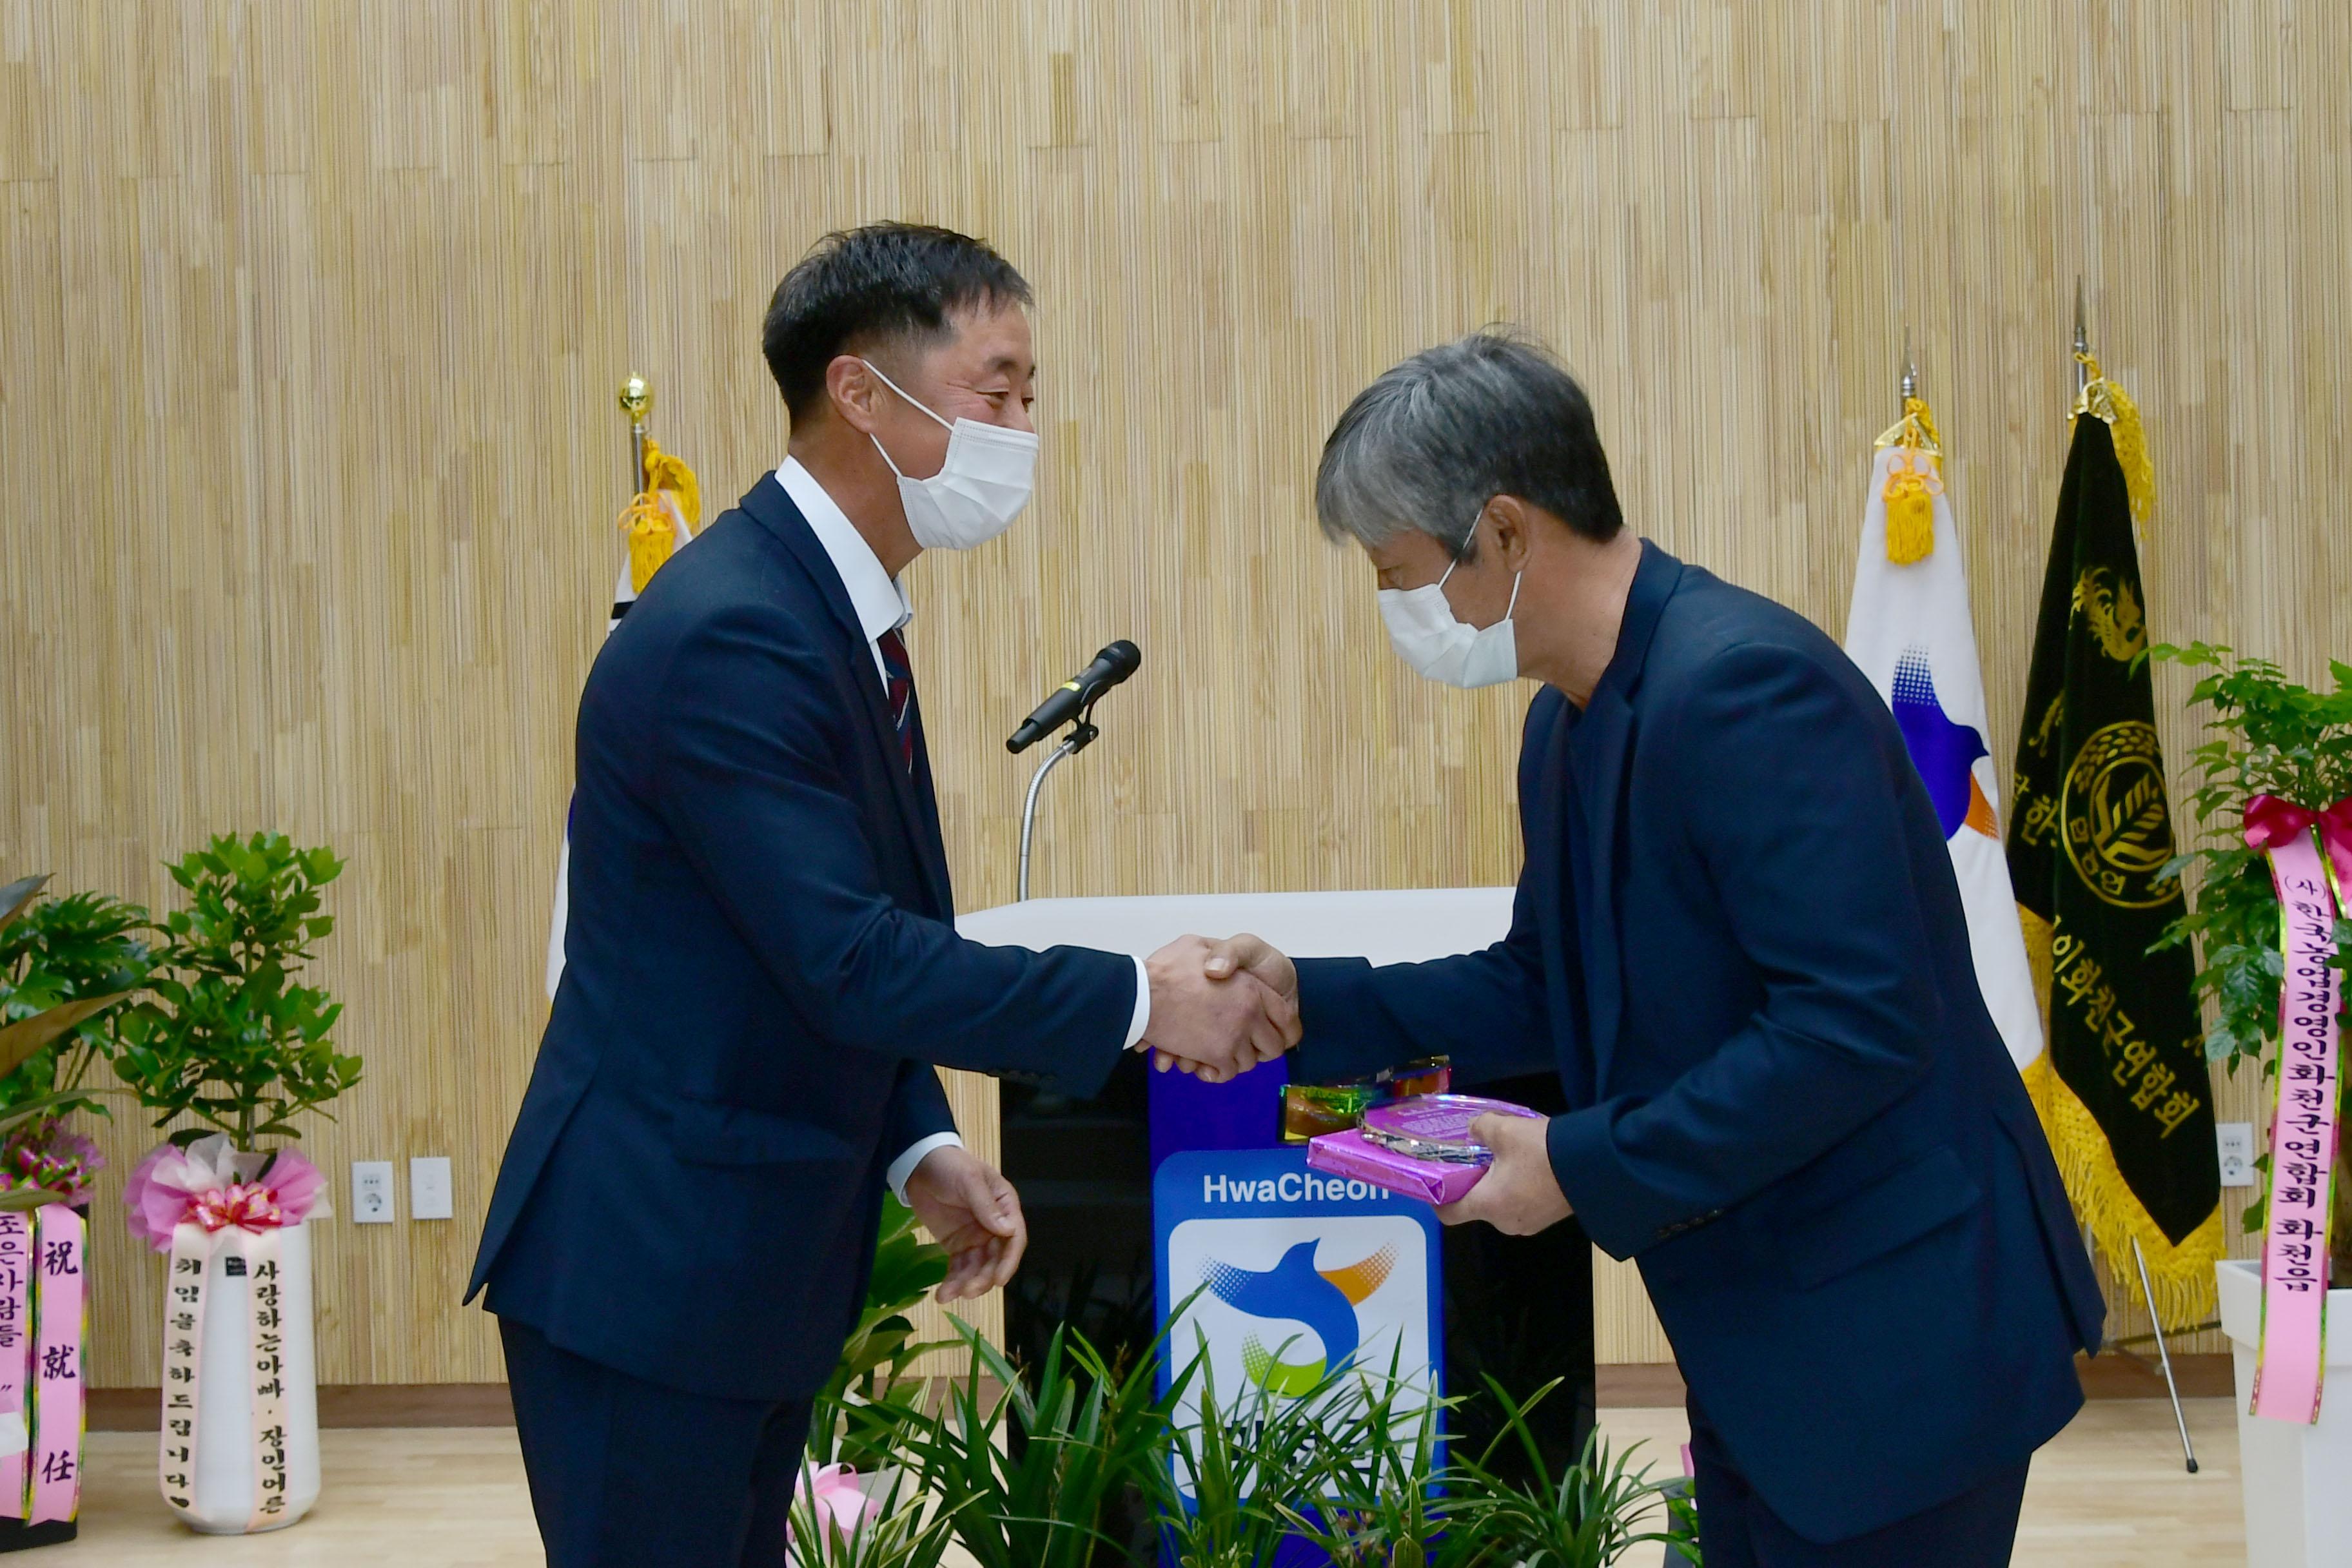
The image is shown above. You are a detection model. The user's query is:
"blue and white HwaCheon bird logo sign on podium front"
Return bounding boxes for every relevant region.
[1153,1147,1442,1481]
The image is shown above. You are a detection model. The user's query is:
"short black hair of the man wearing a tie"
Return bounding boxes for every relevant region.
[760,223,1035,421]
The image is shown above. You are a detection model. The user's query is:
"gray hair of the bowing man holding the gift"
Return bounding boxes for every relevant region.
[1315,327,1625,560]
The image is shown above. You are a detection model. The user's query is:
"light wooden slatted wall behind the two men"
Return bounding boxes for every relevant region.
[0,0,2352,1385]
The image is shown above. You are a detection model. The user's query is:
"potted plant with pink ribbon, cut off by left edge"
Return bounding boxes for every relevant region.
[0,877,148,1551]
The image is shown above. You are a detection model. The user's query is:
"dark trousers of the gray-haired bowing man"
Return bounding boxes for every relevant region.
[1689,1404,2025,1568]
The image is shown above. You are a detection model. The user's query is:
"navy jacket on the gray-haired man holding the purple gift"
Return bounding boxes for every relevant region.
[1298,545,2105,1542]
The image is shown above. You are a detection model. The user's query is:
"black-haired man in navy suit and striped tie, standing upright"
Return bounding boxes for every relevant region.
[468,223,1298,1568]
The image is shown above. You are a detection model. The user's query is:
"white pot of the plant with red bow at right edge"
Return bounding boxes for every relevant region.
[2215,1258,2352,1568]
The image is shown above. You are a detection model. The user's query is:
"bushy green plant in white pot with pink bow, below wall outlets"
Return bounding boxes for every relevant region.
[115,832,360,1535]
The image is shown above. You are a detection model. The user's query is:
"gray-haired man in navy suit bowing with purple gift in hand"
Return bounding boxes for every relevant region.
[1211,334,2105,1568]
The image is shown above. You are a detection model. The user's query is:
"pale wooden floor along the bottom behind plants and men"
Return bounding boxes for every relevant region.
[74,1398,2246,1568]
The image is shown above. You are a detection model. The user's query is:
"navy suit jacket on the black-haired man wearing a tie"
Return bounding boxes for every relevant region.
[468,475,1136,1398]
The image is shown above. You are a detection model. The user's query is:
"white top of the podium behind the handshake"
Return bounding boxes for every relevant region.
[955,888,1513,964]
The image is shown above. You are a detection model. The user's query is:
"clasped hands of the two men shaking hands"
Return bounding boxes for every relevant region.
[1136,936,1298,1084]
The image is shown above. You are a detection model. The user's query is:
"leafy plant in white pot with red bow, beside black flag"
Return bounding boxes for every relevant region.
[2150,644,2352,1563]
